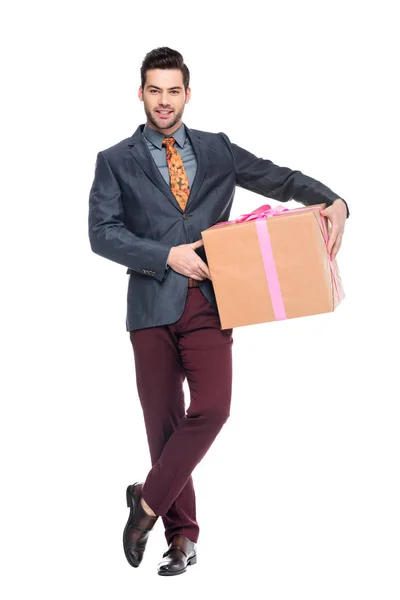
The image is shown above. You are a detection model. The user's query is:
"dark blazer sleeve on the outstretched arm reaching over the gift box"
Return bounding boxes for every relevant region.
[220,132,350,218]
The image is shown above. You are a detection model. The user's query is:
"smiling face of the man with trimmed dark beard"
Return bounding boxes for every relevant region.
[139,69,190,135]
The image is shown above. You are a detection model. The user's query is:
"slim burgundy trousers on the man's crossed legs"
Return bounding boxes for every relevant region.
[129,287,233,544]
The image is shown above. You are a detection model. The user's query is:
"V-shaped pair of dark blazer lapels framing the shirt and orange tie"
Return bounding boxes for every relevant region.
[128,125,208,212]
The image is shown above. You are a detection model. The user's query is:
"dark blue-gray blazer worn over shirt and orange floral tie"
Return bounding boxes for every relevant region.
[89,124,349,331]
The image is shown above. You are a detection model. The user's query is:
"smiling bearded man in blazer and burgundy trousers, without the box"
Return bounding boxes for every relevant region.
[89,47,349,575]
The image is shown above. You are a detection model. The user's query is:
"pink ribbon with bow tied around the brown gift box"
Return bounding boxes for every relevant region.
[212,204,342,321]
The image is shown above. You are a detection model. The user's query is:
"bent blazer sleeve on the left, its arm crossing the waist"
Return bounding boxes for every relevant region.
[88,152,172,281]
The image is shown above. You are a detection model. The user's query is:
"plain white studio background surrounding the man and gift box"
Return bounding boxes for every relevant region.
[0,0,400,600]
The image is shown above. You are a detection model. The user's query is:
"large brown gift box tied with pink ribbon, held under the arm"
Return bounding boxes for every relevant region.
[201,204,344,329]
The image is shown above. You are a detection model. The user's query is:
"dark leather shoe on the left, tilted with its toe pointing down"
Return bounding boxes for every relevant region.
[123,482,158,567]
